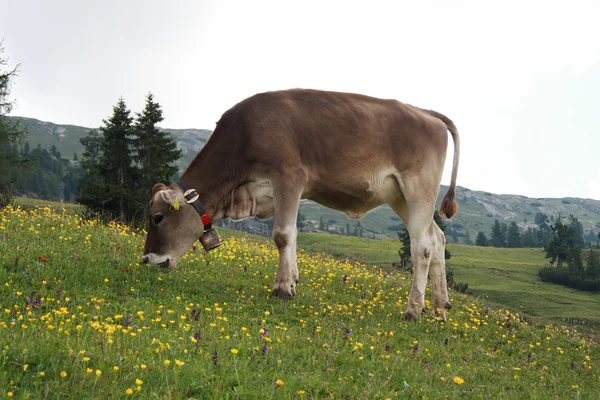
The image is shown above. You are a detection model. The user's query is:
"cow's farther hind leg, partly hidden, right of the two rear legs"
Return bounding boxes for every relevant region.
[429,221,450,320]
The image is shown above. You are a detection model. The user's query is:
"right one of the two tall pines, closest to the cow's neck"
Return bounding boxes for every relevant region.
[133,93,182,216]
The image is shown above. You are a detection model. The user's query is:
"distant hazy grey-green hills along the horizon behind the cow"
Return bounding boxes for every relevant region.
[10,117,600,244]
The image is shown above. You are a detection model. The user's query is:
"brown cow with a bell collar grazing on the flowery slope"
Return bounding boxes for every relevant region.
[142,89,460,319]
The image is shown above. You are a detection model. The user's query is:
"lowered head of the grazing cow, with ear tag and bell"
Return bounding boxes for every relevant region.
[142,183,219,268]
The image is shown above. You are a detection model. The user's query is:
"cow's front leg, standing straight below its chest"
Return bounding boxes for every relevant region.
[273,180,302,299]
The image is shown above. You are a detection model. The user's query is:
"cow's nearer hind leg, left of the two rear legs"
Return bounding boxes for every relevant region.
[391,199,437,319]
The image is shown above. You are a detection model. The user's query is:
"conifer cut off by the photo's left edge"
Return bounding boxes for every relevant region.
[0,42,25,207]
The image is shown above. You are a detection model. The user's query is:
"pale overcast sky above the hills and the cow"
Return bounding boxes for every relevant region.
[0,0,600,200]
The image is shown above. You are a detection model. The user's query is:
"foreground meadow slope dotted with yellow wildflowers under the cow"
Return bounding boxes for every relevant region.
[0,202,600,399]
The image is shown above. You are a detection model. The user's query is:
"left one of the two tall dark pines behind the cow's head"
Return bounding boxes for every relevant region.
[98,98,136,219]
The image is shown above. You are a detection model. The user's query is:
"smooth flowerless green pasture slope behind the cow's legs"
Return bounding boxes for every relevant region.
[298,233,600,335]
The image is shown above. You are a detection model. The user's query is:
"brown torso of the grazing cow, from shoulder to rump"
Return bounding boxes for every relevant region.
[202,89,447,216]
